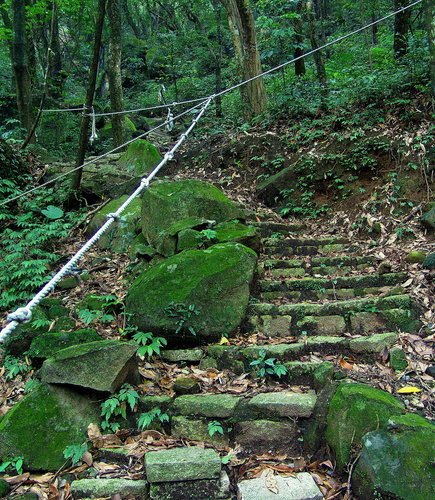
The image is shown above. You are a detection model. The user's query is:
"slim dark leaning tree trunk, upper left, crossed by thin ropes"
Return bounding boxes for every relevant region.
[69,0,107,199]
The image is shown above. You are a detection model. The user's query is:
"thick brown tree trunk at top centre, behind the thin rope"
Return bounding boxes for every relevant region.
[222,0,267,119]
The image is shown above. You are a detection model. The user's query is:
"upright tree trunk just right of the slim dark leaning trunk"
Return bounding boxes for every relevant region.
[107,0,124,146]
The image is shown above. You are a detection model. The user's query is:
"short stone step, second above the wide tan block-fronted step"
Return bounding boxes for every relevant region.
[258,255,376,278]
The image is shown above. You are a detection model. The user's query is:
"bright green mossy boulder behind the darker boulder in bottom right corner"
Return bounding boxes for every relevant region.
[326,382,404,470]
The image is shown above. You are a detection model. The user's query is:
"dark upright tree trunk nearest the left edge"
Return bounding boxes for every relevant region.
[12,0,32,132]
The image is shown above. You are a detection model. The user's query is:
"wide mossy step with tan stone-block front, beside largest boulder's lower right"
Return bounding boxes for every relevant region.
[246,295,421,337]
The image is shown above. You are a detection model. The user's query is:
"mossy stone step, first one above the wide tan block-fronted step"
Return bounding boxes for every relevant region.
[259,273,407,300]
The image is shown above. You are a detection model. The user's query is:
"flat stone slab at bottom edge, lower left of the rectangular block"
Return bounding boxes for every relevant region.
[71,479,149,499]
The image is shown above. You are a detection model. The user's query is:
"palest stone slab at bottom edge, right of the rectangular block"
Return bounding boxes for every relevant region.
[238,472,323,500]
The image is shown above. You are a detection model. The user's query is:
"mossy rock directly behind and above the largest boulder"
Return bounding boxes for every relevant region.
[142,179,244,255]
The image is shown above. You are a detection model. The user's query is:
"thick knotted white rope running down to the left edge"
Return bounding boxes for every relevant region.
[0,96,214,343]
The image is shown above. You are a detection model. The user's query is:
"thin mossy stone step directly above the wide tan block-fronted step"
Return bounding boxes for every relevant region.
[259,273,407,297]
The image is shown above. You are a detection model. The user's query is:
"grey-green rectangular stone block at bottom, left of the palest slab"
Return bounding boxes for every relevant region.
[145,446,221,484]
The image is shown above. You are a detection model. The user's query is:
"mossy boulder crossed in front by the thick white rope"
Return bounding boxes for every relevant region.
[86,195,141,253]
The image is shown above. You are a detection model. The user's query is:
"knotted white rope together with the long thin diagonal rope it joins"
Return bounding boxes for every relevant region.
[0,0,422,344]
